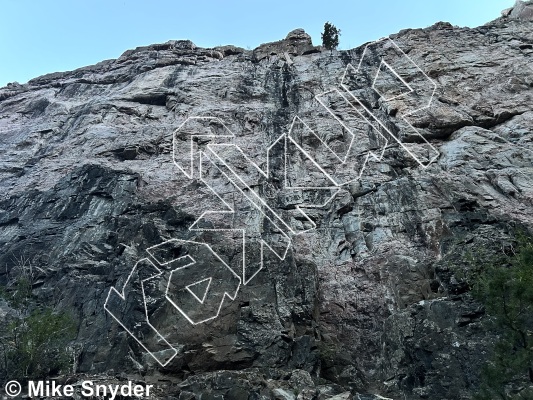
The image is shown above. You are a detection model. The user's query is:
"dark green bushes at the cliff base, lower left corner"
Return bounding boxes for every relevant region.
[0,260,76,381]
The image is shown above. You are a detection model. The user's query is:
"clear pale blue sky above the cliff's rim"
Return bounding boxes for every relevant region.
[0,0,514,87]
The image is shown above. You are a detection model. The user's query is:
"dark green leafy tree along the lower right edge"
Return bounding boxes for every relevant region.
[469,232,533,400]
